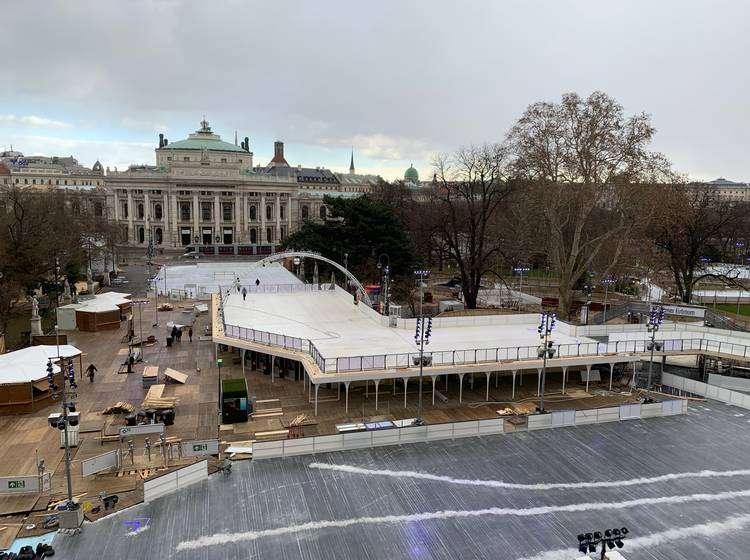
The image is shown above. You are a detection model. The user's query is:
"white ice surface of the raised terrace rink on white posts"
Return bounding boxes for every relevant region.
[224,290,595,358]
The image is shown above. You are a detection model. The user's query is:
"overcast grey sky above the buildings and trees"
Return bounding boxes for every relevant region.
[0,0,750,180]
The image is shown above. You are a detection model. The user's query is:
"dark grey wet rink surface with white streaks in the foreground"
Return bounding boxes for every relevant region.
[55,402,750,560]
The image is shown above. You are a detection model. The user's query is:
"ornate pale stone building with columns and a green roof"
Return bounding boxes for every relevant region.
[105,119,379,250]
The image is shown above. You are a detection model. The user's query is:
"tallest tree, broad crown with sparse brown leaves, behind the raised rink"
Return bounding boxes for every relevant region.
[508,92,671,316]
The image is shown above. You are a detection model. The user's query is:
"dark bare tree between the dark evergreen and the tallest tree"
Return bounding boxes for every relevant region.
[433,144,513,309]
